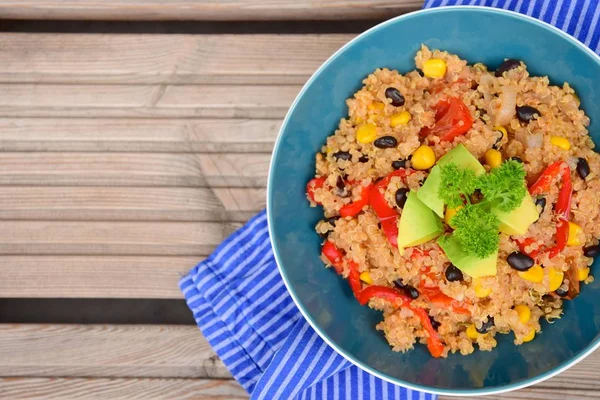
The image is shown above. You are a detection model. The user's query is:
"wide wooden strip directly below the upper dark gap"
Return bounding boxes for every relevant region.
[0,33,355,85]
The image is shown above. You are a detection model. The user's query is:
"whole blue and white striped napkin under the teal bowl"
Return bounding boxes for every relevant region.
[180,0,600,400]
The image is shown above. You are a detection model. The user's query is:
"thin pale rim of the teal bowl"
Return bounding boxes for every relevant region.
[266,5,600,396]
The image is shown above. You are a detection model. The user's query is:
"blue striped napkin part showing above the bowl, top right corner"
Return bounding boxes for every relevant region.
[423,0,600,53]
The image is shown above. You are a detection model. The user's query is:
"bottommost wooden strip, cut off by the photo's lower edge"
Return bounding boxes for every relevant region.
[0,378,248,400]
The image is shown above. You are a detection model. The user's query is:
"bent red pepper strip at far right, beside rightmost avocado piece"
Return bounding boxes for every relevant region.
[524,161,573,258]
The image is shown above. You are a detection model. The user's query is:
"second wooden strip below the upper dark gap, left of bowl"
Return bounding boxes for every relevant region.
[0,83,300,118]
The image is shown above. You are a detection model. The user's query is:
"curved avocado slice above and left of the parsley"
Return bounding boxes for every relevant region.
[418,144,485,218]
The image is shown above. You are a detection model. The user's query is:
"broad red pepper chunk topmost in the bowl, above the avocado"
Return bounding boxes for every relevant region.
[421,97,473,142]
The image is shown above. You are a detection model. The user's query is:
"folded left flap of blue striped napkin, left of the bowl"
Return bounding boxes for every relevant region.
[180,211,299,393]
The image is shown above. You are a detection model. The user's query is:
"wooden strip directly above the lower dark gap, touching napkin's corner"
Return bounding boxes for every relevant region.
[0,255,203,296]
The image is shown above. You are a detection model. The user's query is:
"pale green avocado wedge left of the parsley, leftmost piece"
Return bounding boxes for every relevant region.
[398,191,444,252]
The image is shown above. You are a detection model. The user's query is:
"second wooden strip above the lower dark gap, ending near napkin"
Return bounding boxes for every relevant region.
[0,221,241,256]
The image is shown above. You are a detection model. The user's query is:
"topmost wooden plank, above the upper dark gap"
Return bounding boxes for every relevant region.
[0,0,423,21]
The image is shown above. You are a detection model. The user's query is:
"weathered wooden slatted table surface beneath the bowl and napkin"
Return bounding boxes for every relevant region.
[0,0,600,400]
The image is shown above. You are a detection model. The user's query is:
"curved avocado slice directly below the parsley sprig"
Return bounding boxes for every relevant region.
[438,236,498,278]
